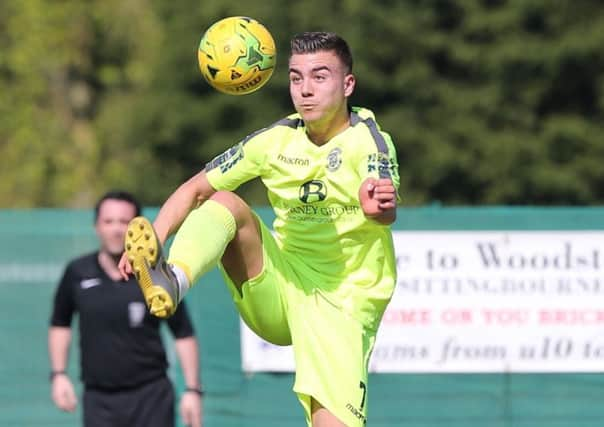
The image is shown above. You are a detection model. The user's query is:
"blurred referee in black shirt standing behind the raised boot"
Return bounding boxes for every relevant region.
[48,191,201,427]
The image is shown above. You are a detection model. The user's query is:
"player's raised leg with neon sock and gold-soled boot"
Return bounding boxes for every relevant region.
[125,191,262,317]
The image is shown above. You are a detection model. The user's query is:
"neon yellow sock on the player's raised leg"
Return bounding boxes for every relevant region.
[168,200,237,286]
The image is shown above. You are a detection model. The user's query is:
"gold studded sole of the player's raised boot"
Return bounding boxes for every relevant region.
[124,216,176,318]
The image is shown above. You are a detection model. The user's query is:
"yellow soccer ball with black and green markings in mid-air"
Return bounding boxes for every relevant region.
[197,16,277,95]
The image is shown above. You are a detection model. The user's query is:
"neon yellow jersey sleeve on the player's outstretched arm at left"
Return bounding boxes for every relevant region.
[205,134,267,191]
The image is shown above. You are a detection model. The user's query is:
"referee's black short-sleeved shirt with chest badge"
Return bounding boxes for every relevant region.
[50,252,193,390]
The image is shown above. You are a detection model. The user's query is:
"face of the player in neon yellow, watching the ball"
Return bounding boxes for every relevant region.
[289,51,355,126]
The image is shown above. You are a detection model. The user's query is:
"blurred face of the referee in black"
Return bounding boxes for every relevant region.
[95,199,136,257]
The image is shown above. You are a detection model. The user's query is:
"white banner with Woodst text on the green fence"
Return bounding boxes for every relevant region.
[241,231,604,373]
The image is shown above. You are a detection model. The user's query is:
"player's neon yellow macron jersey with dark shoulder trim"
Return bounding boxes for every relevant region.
[206,107,399,329]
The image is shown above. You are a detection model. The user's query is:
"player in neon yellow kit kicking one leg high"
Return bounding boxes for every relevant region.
[120,32,399,427]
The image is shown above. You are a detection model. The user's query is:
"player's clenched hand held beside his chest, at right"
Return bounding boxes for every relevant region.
[359,178,396,224]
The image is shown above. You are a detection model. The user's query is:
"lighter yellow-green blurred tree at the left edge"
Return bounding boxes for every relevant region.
[0,0,163,207]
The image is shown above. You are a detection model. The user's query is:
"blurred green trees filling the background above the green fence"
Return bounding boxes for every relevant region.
[0,0,604,208]
